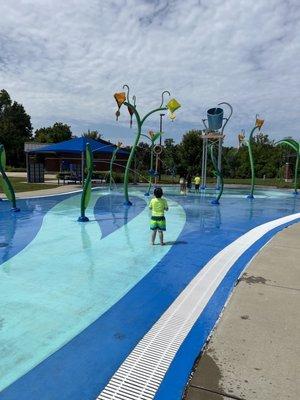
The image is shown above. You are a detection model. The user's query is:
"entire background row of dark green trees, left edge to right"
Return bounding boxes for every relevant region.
[0,89,295,178]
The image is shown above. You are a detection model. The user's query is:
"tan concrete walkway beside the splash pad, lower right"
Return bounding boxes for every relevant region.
[186,224,300,400]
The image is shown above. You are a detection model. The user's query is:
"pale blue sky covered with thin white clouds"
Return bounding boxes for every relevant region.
[0,0,300,145]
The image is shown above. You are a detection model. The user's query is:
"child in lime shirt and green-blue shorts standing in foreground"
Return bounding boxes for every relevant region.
[149,187,169,246]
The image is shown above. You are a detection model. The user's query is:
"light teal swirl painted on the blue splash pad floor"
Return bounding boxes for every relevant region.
[0,192,185,390]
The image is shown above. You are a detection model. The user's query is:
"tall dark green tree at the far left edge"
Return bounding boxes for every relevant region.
[0,89,32,167]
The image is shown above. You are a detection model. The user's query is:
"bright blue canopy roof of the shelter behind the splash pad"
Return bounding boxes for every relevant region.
[30,136,128,154]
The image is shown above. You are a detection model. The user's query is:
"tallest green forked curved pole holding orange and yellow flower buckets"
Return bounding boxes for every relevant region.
[124,99,167,206]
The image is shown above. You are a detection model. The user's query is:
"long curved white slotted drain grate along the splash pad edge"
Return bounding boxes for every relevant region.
[97,213,300,400]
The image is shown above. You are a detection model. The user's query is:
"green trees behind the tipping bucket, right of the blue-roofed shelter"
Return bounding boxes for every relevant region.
[137,130,296,179]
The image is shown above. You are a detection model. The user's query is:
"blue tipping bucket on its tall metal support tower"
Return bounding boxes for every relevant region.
[201,102,233,189]
